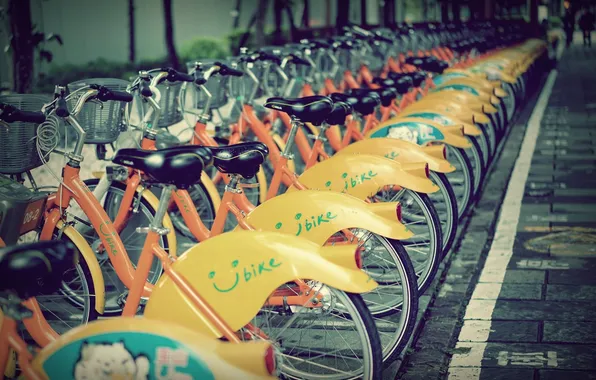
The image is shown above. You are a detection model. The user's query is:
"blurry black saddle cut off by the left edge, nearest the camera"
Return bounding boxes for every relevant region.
[0,240,78,299]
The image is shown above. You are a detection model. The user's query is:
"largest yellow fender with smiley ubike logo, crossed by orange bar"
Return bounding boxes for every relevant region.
[145,229,377,337]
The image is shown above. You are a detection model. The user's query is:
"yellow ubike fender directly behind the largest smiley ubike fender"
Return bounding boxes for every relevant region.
[244,190,413,245]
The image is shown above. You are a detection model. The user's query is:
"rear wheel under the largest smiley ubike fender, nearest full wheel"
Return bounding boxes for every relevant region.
[247,281,383,380]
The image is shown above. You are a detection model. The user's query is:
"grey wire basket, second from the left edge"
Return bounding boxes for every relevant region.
[68,78,128,144]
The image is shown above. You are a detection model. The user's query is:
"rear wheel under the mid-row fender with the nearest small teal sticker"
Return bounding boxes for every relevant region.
[447,145,474,218]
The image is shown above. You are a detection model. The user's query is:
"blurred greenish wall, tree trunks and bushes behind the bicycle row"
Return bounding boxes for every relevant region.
[0,0,596,93]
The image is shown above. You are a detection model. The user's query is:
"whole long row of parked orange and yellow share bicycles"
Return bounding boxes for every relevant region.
[0,23,548,379]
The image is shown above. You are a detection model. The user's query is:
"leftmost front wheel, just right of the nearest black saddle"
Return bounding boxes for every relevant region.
[23,229,99,338]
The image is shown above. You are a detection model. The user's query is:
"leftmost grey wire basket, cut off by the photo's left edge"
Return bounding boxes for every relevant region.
[0,94,52,174]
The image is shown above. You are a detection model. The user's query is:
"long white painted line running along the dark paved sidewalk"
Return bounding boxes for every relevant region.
[449,70,557,380]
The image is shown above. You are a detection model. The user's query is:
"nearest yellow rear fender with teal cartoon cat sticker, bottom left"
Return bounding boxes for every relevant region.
[31,318,276,380]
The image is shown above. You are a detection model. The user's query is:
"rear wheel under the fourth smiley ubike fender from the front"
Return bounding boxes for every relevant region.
[428,171,459,257]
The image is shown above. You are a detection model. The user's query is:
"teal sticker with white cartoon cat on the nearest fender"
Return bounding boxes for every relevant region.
[42,331,214,380]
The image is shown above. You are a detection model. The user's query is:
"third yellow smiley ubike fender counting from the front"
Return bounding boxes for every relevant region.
[292,154,439,196]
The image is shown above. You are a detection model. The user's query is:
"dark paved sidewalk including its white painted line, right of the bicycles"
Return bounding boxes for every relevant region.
[449,46,596,380]
